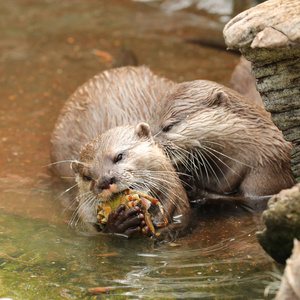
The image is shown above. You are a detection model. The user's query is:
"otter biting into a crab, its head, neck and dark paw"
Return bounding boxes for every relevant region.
[72,123,191,240]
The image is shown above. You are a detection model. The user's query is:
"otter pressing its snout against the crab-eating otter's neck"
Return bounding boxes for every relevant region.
[149,80,295,203]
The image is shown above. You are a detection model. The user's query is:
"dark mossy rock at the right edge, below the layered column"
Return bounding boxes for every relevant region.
[257,183,300,264]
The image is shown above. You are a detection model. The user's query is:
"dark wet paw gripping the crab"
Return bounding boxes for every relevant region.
[102,204,150,236]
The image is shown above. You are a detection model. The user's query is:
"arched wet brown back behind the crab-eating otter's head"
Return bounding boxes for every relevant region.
[50,66,173,177]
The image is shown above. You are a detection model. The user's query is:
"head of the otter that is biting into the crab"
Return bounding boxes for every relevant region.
[71,123,159,197]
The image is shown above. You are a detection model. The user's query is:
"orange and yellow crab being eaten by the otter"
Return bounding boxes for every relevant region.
[96,189,168,234]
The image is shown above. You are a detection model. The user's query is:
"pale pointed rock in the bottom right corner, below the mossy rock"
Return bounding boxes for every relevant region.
[275,240,300,300]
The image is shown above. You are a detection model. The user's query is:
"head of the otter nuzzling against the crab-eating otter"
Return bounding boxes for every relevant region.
[150,80,234,160]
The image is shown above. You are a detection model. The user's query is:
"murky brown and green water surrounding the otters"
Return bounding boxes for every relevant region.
[0,0,282,299]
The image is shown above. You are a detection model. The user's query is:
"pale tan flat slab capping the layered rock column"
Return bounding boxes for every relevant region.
[224,0,300,49]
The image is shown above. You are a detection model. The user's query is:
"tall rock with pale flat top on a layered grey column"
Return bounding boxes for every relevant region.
[223,0,300,181]
